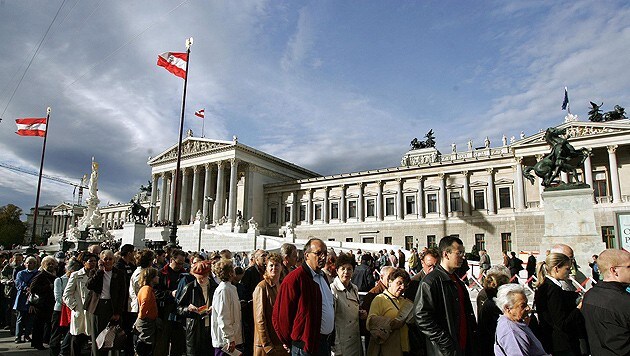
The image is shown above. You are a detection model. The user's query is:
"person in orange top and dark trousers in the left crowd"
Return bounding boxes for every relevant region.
[134,267,158,356]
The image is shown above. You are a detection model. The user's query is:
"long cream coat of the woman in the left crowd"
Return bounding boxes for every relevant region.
[61,268,92,336]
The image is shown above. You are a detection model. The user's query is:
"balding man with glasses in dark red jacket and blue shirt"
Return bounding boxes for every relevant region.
[272,239,335,356]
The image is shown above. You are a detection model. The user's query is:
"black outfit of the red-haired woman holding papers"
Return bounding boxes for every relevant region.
[177,278,219,356]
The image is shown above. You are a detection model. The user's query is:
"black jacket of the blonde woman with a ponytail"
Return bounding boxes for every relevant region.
[534,278,586,355]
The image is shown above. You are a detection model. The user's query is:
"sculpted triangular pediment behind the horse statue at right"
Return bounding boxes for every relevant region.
[511,120,630,147]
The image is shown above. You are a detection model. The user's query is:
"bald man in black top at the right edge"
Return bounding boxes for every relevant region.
[582,249,630,355]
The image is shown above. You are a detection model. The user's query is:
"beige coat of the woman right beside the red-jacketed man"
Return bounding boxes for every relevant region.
[330,277,362,356]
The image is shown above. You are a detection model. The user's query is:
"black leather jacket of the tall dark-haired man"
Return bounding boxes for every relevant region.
[415,265,477,356]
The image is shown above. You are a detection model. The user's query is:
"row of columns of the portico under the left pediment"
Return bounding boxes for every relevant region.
[156,159,239,224]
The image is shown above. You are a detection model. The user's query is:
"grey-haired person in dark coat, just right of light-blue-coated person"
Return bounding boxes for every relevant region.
[30,256,57,350]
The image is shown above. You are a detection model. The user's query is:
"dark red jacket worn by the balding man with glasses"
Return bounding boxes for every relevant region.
[272,264,322,354]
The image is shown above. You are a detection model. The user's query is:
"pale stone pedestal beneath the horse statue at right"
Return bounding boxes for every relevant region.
[540,188,606,276]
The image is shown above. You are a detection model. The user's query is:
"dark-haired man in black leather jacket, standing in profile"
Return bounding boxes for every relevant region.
[415,236,477,355]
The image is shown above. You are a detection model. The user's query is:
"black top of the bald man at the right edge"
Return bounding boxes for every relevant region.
[582,281,630,356]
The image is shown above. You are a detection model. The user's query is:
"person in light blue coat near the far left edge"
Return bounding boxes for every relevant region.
[13,256,39,344]
